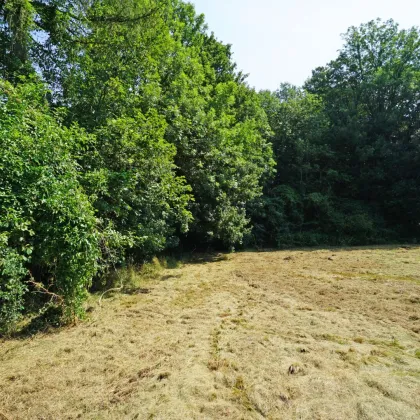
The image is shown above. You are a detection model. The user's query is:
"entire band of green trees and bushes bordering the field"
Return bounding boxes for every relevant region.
[0,0,420,331]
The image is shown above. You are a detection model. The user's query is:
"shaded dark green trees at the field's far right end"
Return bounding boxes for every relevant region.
[253,21,420,246]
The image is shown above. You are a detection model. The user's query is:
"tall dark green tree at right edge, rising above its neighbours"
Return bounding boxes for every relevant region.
[306,20,420,235]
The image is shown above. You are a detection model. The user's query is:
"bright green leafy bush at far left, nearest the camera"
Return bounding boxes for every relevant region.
[0,80,99,332]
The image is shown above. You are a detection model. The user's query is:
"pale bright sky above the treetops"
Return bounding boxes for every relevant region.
[191,0,420,90]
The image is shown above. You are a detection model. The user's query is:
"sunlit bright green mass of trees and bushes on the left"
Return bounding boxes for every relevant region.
[0,0,274,332]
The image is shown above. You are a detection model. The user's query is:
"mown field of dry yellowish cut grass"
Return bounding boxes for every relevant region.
[0,246,420,420]
